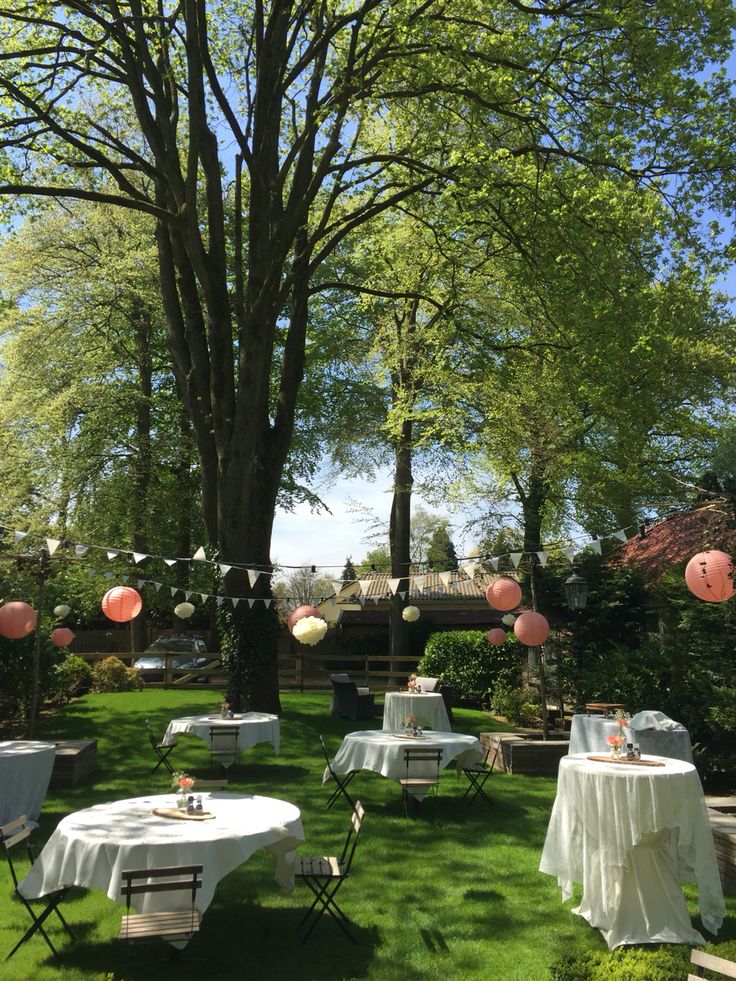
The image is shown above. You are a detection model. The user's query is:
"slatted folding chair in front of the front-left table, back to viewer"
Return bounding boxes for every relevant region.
[120,865,203,943]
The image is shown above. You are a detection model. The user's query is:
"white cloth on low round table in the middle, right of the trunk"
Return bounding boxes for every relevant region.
[323,729,483,782]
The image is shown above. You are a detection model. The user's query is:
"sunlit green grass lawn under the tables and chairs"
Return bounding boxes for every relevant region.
[0,690,736,981]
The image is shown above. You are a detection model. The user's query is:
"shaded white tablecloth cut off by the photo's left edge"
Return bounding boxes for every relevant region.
[0,739,56,828]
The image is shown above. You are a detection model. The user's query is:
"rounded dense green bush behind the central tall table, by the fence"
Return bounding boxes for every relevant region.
[417,630,522,705]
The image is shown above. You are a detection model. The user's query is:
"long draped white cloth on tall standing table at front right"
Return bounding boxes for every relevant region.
[539,754,725,949]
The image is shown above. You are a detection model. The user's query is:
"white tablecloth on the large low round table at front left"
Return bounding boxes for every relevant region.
[19,792,304,913]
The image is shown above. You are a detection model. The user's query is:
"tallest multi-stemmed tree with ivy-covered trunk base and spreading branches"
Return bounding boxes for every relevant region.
[0,0,733,708]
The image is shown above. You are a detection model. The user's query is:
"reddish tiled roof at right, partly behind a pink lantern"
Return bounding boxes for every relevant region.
[609,506,736,579]
